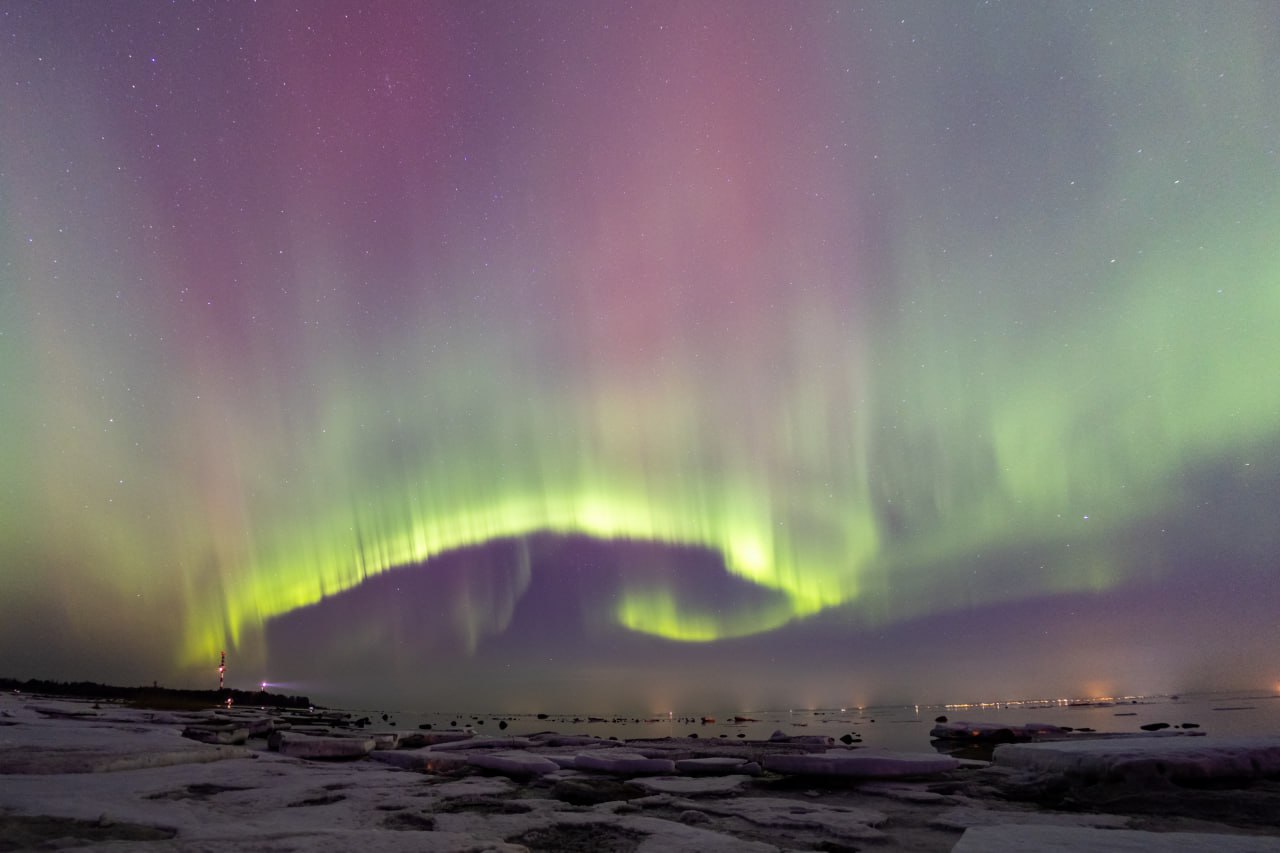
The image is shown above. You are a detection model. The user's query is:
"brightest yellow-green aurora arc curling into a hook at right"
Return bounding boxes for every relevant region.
[186,484,876,663]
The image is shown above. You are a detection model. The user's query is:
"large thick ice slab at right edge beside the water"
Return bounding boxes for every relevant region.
[992,736,1280,781]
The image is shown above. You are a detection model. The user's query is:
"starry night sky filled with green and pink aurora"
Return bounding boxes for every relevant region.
[0,0,1280,711]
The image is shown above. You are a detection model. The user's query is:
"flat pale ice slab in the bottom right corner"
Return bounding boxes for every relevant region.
[951,824,1280,853]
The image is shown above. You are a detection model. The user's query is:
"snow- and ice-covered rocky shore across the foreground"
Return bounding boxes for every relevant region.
[0,694,1280,853]
